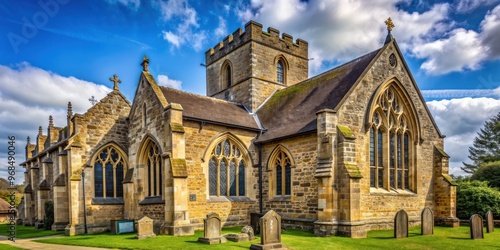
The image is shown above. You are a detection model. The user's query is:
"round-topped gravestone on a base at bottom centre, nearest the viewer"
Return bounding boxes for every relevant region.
[250,210,285,250]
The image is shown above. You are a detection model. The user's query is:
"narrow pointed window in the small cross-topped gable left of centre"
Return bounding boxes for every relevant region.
[142,140,163,196]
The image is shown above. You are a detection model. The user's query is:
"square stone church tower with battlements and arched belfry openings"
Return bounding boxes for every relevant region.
[205,21,309,112]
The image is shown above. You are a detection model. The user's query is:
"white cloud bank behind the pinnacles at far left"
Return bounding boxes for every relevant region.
[0,62,111,184]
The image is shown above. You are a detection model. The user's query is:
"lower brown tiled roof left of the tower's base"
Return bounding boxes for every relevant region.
[160,86,259,130]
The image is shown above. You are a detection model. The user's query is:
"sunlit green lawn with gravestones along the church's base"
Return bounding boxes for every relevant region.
[29,226,500,250]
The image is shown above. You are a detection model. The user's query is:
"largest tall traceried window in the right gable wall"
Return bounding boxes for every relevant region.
[369,85,416,190]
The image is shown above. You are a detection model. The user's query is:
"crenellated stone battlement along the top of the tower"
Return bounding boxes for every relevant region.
[205,21,308,65]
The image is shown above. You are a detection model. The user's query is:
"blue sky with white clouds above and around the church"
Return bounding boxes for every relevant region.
[0,0,500,184]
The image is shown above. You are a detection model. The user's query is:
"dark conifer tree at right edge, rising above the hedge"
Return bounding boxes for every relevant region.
[461,112,500,174]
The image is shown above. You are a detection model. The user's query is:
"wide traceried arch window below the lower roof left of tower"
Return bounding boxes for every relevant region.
[208,138,247,196]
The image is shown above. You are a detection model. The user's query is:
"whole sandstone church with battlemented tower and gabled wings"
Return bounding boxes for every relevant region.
[21,20,459,238]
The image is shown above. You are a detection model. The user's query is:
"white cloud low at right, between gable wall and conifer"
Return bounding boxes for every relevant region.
[427,97,500,175]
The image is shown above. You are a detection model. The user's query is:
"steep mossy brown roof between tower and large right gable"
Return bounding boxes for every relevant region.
[256,49,380,142]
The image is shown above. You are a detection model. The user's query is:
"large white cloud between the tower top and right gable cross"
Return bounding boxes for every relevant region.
[238,0,449,74]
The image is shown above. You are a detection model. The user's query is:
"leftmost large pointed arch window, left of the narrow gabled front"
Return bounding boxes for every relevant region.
[93,145,125,198]
